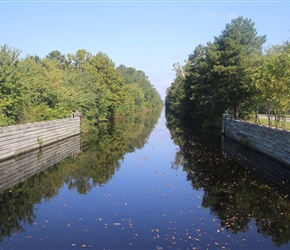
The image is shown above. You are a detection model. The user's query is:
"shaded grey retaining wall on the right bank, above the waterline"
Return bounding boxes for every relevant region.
[224,119,290,165]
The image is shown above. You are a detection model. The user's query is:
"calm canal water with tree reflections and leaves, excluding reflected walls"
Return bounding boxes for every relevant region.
[0,108,290,249]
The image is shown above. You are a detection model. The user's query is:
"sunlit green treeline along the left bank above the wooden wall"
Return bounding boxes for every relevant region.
[0,45,162,126]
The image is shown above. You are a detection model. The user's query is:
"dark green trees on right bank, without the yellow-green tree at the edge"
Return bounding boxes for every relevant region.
[166,17,266,125]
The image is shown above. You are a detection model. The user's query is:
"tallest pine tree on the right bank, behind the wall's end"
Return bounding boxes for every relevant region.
[211,17,266,119]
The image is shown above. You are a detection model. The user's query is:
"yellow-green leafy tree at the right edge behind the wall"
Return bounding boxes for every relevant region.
[250,42,290,126]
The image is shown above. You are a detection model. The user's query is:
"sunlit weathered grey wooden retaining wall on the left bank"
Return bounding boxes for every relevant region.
[0,117,81,161]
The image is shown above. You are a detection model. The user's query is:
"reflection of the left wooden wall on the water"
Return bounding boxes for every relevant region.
[0,135,81,192]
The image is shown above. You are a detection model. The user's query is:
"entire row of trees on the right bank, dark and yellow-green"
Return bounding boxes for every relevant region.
[165,17,290,127]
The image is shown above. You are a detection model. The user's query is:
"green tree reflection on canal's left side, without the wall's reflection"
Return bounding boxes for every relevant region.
[0,109,161,242]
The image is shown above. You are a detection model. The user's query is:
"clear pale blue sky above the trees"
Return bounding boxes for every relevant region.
[0,0,290,98]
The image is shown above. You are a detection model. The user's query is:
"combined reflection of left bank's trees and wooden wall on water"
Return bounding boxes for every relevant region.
[0,107,161,242]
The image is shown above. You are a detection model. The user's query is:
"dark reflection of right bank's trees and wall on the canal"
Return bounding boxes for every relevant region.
[167,116,290,247]
